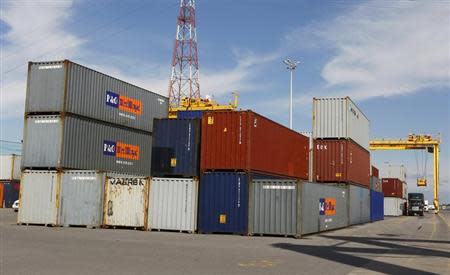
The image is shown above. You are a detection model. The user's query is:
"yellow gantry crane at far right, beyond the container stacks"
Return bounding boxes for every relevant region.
[370,134,441,213]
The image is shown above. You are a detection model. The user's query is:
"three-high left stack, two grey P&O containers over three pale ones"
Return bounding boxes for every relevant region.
[18,60,168,231]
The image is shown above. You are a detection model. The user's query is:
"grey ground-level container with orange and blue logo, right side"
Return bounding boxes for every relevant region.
[301,182,349,235]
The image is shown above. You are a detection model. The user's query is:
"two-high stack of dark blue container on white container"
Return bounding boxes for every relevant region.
[148,116,201,232]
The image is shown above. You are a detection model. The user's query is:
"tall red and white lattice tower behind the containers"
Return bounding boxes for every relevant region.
[169,0,200,107]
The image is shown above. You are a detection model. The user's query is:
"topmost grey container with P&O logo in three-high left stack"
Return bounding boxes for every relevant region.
[25,60,168,132]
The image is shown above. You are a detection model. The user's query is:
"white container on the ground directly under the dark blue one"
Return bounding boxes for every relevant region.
[148,178,199,233]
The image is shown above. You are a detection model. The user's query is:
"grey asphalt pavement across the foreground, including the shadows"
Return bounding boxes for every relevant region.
[0,209,450,274]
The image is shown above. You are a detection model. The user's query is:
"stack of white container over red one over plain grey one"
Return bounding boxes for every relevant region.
[313,97,371,224]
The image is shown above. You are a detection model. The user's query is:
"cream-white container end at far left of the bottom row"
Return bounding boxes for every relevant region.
[17,170,61,225]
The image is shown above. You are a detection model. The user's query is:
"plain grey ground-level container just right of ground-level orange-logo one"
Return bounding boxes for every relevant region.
[348,185,370,225]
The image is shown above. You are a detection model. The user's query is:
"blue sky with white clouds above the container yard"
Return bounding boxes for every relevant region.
[0,0,450,202]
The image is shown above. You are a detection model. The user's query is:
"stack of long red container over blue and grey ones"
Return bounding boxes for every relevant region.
[199,111,309,235]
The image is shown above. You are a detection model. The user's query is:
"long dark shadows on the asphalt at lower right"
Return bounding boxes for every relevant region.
[272,235,450,274]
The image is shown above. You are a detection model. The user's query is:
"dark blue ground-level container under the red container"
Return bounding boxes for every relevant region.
[198,172,249,234]
